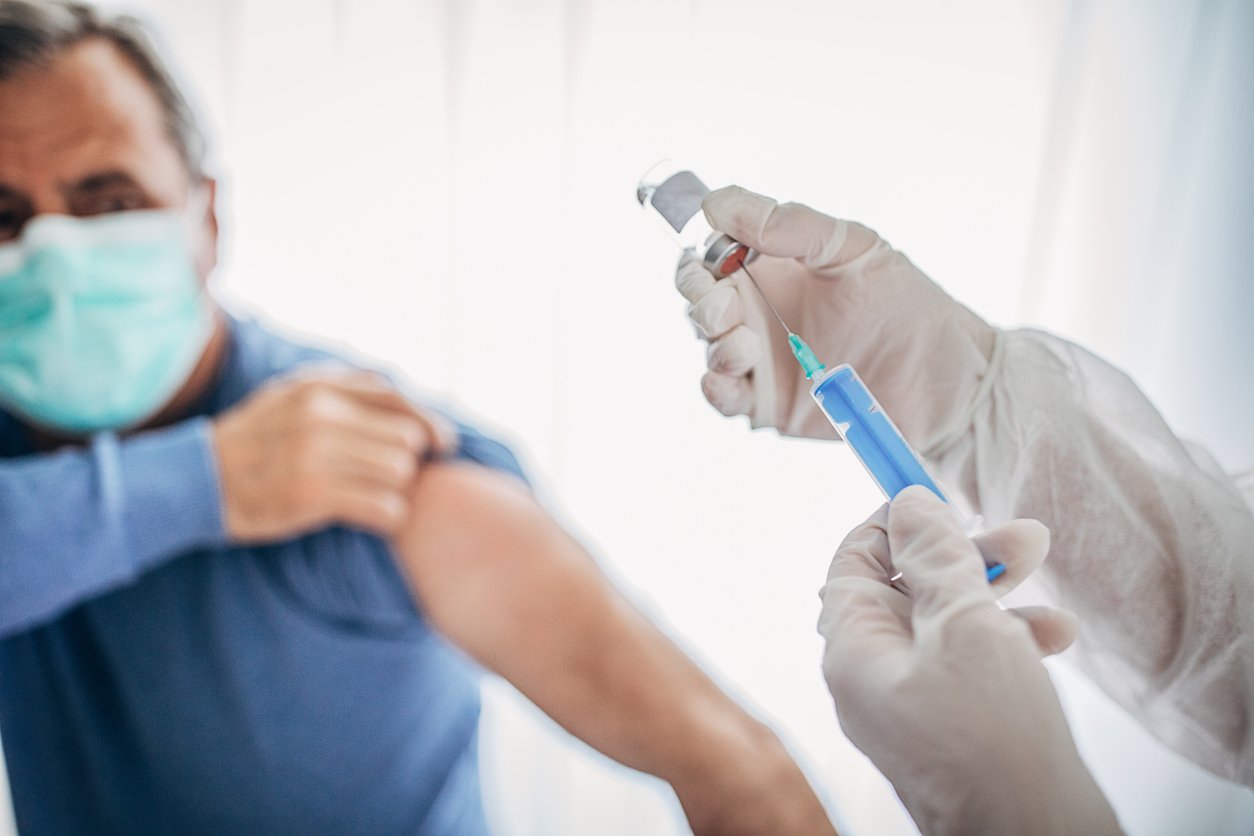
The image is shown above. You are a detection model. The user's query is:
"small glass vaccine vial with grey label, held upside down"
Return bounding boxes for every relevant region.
[636,160,757,278]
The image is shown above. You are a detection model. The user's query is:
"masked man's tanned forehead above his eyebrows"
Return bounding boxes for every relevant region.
[0,38,182,198]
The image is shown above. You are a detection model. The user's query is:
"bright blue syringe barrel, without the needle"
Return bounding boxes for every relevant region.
[810,365,949,503]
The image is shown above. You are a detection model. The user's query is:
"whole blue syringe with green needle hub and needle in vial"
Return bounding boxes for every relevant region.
[740,263,1006,583]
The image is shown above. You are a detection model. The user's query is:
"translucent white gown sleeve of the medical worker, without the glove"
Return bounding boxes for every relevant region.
[927,330,1254,786]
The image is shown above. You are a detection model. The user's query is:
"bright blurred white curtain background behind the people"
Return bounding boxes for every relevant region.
[0,0,1254,836]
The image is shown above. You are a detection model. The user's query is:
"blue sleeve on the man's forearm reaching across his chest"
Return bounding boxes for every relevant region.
[0,419,227,637]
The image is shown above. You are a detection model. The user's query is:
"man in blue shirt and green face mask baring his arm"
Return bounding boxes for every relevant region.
[0,0,831,835]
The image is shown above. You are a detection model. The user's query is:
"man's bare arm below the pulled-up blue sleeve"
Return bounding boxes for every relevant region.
[394,464,834,833]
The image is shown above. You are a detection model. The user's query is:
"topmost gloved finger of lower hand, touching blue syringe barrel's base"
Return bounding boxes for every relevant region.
[888,485,993,624]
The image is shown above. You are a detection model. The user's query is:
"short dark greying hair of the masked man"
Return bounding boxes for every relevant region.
[0,0,207,178]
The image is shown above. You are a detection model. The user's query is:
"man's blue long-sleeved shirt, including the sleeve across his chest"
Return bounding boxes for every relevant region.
[0,320,522,836]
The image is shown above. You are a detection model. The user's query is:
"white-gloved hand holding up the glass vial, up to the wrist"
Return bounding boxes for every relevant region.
[676,185,994,449]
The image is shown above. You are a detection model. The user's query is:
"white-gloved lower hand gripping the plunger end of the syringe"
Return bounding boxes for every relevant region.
[819,488,1119,836]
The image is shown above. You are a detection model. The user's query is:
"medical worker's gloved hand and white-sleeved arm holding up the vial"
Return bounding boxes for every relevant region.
[676,188,1254,786]
